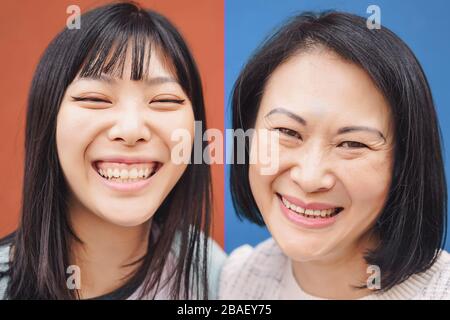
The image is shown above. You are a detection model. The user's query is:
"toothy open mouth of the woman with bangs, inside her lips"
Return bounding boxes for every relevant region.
[93,161,162,184]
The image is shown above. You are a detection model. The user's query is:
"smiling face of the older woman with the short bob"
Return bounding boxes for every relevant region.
[249,51,393,261]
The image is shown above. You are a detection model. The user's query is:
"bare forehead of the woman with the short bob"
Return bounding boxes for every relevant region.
[261,50,390,122]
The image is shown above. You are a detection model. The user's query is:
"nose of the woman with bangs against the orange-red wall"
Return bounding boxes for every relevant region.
[108,108,151,146]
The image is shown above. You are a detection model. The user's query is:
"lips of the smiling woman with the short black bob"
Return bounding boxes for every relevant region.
[277,196,338,229]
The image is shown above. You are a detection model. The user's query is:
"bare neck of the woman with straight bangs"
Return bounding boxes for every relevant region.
[69,199,151,299]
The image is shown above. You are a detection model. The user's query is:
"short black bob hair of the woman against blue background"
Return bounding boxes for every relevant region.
[230,11,447,291]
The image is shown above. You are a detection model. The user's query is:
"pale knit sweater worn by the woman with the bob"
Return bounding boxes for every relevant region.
[219,238,450,300]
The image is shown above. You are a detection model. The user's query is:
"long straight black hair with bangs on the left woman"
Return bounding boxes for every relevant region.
[2,2,212,299]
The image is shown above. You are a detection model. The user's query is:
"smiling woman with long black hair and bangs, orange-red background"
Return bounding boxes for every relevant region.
[0,3,222,299]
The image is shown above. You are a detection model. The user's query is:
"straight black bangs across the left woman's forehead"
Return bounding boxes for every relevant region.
[77,5,198,107]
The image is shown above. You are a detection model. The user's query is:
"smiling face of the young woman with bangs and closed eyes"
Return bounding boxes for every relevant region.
[56,53,194,226]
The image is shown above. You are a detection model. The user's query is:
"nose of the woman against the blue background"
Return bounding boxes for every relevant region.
[290,146,336,193]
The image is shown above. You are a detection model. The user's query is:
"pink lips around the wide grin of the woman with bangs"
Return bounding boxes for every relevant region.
[91,157,162,193]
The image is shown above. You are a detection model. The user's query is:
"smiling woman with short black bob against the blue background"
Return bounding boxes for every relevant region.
[219,12,450,299]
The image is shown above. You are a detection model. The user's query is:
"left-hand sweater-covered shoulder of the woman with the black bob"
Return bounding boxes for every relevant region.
[219,238,288,299]
